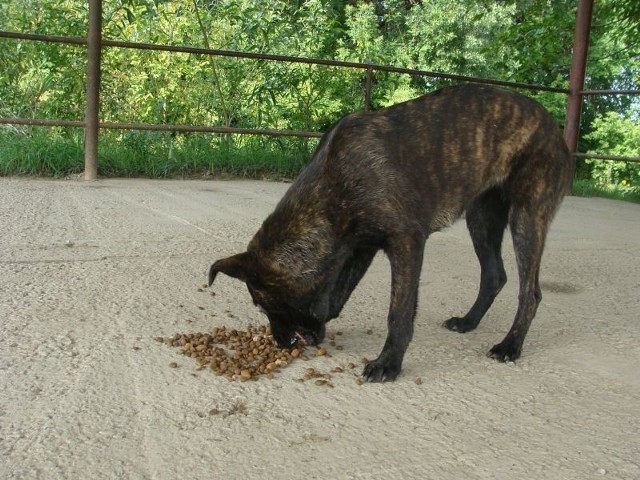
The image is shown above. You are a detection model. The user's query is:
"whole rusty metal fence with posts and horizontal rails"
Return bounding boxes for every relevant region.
[0,0,640,180]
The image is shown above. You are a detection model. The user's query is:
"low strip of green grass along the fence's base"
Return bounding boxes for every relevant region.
[0,128,640,203]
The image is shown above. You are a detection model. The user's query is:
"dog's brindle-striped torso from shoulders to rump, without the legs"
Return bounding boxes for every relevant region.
[300,85,574,235]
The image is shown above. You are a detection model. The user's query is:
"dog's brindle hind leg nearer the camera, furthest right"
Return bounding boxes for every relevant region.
[489,205,552,362]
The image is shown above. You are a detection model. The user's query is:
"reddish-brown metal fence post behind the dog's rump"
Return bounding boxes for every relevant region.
[564,0,593,154]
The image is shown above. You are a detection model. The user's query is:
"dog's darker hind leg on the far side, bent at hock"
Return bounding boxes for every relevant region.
[442,187,509,333]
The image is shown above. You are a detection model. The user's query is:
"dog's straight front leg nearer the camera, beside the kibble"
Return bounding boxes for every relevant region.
[362,232,426,382]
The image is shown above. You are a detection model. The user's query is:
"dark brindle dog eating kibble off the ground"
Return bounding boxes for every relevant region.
[209,85,574,382]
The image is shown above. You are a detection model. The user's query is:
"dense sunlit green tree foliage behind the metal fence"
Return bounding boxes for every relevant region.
[0,0,640,181]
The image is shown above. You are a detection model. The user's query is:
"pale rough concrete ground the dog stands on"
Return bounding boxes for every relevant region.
[0,178,640,480]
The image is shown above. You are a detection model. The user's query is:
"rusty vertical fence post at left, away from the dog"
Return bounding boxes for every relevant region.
[84,0,102,180]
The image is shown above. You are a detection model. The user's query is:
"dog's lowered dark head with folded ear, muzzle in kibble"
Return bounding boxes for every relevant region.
[209,251,328,348]
